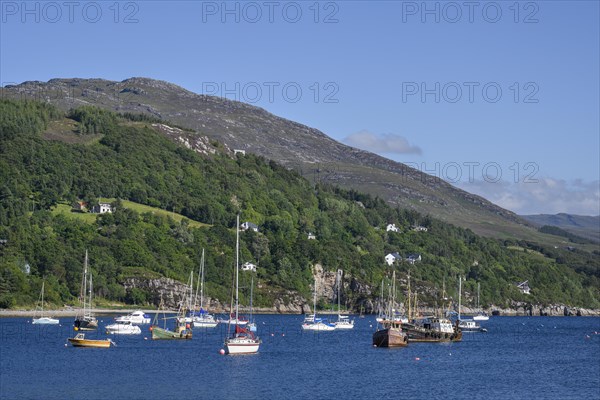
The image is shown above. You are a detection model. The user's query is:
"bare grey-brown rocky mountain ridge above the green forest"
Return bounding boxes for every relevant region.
[2,78,537,238]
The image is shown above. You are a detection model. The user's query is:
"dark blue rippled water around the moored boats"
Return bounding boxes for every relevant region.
[0,315,600,400]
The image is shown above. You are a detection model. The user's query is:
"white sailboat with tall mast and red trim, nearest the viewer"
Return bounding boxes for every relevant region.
[225,214,261,354]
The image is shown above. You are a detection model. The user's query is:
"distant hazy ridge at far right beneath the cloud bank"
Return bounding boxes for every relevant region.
[521,213,600,243]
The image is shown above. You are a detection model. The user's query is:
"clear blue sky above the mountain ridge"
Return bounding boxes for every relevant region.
[0,0,600,215]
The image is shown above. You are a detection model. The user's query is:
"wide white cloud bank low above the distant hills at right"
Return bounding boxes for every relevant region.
[456,178,600,215]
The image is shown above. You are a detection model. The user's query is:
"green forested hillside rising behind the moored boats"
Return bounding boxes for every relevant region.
[0,100,600,308]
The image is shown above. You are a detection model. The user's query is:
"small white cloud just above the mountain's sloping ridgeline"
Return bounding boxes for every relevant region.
[342,130,421,154]
